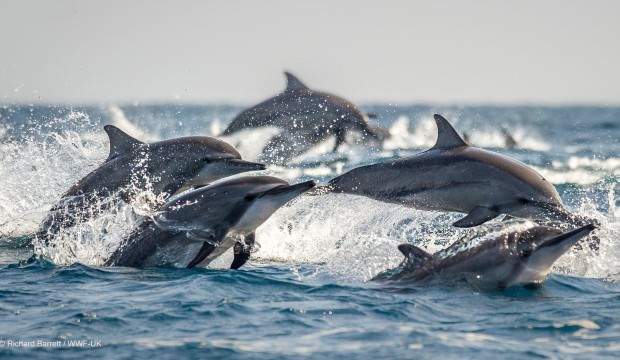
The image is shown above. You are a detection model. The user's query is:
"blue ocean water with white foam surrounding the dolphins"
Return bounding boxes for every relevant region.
[0,104,620,359]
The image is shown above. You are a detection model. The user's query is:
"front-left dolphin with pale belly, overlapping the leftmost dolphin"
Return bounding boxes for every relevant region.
[106,176,315,269]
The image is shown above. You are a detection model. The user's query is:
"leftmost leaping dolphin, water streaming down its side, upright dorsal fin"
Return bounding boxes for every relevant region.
[37,125,265,244]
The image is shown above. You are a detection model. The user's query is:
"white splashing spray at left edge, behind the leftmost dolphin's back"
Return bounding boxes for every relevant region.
[0,113,108,237]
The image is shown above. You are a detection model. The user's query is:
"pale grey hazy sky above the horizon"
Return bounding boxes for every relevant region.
[0,0,620,104]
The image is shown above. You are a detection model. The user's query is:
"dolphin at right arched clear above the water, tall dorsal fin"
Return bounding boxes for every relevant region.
[323,115,572,227]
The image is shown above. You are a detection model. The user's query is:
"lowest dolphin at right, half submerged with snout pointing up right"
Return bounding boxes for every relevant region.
[374,224,595,288]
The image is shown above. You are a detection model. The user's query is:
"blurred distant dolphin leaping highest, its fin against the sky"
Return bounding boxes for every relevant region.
[222,72,388,163]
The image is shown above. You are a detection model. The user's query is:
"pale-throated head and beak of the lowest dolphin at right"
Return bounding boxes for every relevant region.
[502,224,596,286]
